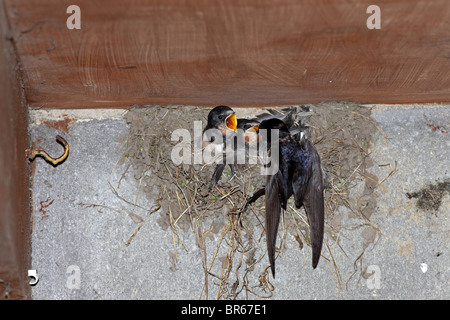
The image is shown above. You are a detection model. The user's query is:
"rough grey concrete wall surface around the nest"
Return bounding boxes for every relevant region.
[30,104,450,299]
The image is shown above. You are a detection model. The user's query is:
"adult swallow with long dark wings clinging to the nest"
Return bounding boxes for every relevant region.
[259,118,324,277]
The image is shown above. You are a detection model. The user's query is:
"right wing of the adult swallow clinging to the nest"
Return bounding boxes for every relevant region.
[303,141,325,268]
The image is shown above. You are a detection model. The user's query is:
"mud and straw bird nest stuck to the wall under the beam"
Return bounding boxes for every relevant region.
[116,102,381,299]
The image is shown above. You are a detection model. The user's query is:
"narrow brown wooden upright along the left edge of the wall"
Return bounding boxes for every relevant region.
[0,0,31,299]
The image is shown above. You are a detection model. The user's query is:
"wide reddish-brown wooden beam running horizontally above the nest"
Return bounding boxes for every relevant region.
[4,0,450,108]
